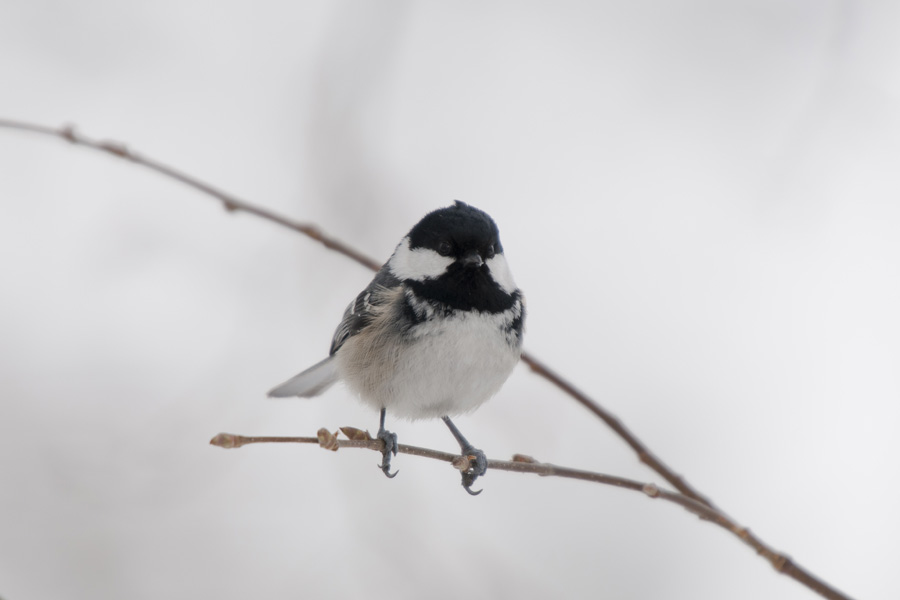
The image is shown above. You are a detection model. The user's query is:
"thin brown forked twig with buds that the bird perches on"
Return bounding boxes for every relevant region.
[0,119,850,600]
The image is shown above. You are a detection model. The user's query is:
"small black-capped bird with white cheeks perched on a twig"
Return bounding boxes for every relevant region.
[269,200,525,495]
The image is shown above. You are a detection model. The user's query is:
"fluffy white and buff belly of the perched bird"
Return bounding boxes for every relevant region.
[336,313,520,419]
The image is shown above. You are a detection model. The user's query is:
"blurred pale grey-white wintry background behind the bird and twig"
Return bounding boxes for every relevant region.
[0,0,900,600]
